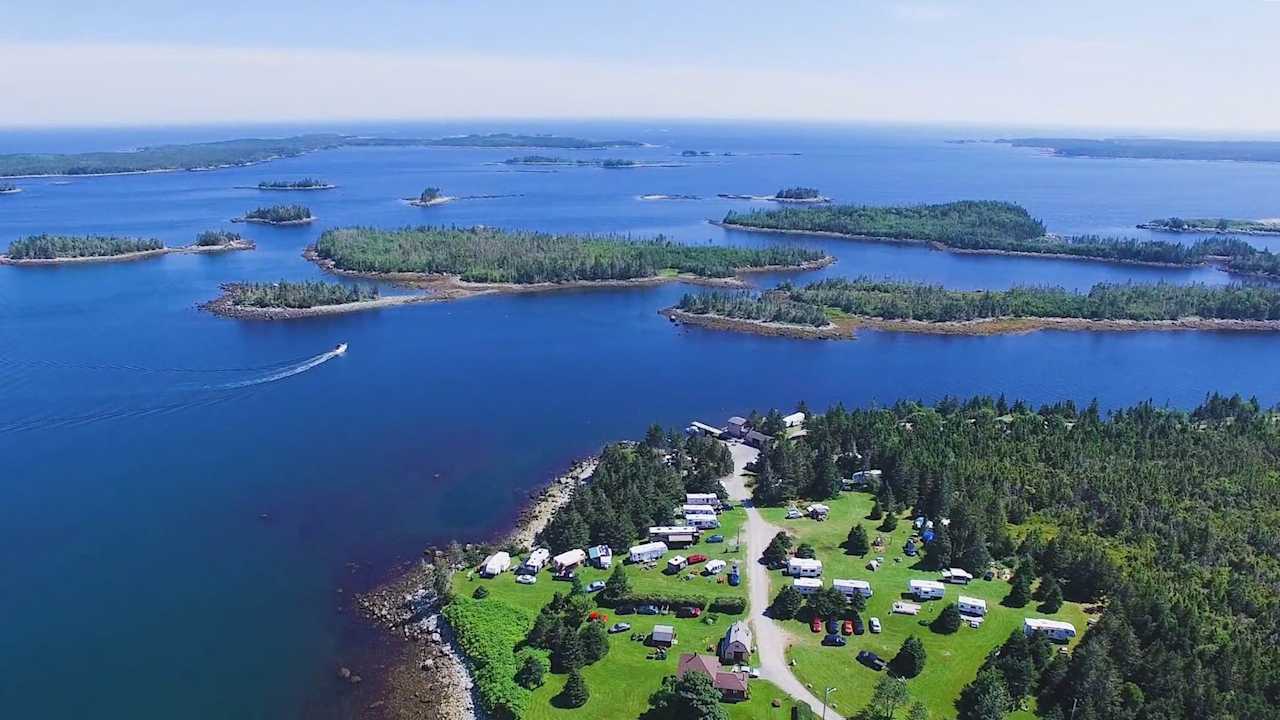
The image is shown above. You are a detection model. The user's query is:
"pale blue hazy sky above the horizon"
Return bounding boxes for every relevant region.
[0,0,1280,132]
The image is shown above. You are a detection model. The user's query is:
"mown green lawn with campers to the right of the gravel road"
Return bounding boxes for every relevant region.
[760,493,1085,717]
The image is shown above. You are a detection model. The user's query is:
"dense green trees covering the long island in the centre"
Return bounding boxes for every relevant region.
[314,227,829,284]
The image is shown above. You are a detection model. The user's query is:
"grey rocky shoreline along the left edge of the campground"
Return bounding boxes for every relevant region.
[353,457,598,720]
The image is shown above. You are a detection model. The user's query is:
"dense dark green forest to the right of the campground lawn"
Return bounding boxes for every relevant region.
[755,395,1280,720]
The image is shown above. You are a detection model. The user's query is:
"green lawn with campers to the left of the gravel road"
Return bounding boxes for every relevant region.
[453,509,790,720]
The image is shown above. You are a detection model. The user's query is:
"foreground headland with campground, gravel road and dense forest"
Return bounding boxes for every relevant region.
[361,393,1280,720]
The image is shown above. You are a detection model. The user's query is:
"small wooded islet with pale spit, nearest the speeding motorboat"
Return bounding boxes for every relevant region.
[201,281,430,320]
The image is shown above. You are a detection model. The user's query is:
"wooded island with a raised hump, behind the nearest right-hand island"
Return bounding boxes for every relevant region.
[717,200,1280,278]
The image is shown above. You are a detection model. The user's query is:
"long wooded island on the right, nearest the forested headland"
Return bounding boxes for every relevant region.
[663,278,1280,337]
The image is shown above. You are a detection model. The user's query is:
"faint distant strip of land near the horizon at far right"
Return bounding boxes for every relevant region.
[996,137,1280,163]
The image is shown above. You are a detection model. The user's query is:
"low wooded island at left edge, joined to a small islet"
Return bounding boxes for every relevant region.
[0,231,255,265]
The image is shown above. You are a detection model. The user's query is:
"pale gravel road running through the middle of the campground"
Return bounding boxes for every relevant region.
[722,443,842,720]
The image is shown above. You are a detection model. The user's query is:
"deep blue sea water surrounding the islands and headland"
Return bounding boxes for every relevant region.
[0,123,1280,719]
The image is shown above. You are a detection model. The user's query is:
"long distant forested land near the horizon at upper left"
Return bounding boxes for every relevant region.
[0,133,643,177]
